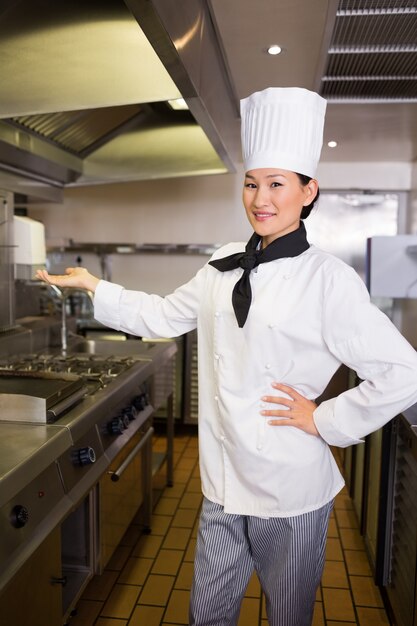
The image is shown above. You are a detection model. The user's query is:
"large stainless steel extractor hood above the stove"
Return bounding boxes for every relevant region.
[0,0,238,193]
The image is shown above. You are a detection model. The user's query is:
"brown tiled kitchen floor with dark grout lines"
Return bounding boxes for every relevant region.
[70,435,390,626]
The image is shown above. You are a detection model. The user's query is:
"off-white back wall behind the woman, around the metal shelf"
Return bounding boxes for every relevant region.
[29,157,417,294]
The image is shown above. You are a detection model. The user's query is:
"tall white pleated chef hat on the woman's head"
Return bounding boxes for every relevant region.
[240,87,327,178]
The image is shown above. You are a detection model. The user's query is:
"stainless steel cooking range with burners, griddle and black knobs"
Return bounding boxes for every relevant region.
[0,353,153,626]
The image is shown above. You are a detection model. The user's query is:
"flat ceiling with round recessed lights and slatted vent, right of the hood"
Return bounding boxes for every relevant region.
[210,0,417,161]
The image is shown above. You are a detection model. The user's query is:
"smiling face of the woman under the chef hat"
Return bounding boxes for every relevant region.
[243,168,318,248]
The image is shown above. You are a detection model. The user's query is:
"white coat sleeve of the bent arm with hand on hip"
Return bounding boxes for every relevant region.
[314,267,417,447]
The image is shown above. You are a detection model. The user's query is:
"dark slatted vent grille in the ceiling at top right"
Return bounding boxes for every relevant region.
[321,0,417,102]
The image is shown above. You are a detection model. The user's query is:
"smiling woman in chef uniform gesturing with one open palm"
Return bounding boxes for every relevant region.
[38,88,417,626]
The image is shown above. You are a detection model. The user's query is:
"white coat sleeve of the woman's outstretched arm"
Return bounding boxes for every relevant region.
[94,265,207,338]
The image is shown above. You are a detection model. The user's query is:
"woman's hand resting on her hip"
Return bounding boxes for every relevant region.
[261,383,319,436]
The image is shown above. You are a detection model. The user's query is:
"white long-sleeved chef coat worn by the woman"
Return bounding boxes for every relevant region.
[95,243,417,517]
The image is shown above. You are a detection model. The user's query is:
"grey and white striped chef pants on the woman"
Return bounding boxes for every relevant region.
[190,498,333,626]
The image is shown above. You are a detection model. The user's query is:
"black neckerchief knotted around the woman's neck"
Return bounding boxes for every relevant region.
[209,222,310,328]
